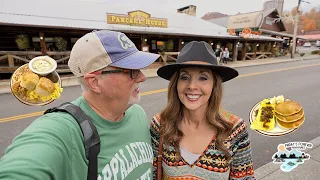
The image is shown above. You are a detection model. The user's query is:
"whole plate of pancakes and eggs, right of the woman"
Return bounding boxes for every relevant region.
[249,95,305,136]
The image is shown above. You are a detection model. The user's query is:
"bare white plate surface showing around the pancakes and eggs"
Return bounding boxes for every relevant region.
[249,101,298,137]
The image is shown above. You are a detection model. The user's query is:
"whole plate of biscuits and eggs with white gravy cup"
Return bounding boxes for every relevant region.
[10,56,63,106]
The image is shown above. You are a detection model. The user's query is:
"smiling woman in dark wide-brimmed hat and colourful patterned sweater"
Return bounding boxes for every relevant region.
[151,41,254,180]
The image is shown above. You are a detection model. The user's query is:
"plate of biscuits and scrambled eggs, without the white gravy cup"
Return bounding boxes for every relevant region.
[10,63,62,106]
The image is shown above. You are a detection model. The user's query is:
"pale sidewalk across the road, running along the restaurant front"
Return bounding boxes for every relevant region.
[0,55,320,94]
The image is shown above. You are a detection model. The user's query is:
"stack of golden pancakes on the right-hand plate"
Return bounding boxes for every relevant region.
[274,101,305,129]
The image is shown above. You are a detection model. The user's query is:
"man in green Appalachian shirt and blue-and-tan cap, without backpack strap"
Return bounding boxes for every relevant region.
[0,31,159,180]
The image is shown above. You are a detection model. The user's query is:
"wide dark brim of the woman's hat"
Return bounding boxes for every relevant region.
[157,63,239,82]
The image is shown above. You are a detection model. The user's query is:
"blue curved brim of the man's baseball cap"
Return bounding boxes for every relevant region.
[110,51,160,69]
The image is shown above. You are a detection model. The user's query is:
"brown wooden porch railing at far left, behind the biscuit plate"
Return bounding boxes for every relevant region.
[0,51,70,73]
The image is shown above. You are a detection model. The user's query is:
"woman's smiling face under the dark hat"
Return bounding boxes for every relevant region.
[177,67,214,111]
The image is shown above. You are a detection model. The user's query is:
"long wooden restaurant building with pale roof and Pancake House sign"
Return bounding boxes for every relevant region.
[0,0,281,73]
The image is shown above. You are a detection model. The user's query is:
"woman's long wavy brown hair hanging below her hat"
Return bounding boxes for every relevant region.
[160,71,233,161]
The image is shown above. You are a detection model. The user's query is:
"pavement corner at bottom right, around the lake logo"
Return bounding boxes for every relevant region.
[255,136,320,180]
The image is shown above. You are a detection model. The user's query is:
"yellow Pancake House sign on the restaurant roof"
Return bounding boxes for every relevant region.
[107,10,168,28]
